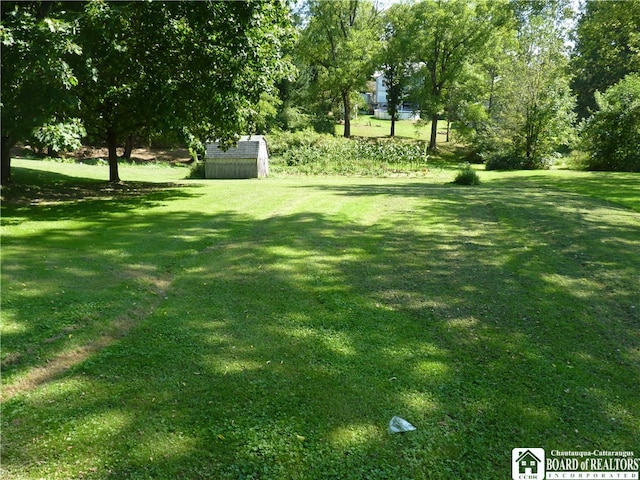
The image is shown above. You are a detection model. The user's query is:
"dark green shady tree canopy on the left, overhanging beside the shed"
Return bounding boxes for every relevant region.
[2,0,293,182]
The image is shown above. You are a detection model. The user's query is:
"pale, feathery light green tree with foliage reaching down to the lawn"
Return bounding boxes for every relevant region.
[480,0,575,169]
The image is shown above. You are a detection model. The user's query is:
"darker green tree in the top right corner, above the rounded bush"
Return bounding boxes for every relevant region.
[572,0,640,118]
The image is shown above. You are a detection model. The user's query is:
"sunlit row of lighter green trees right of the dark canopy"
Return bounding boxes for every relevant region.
[295,0,640,170]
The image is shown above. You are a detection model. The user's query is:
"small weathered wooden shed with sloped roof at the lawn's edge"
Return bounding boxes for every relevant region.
[204,135,269,178]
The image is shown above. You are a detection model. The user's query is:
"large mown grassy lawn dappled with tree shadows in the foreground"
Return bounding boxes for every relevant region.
[0,160,640,480]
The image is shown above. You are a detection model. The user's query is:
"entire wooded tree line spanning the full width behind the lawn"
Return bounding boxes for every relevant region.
[0,0,640,183]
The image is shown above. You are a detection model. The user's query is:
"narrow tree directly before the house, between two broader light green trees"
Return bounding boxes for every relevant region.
[379,4,413,137]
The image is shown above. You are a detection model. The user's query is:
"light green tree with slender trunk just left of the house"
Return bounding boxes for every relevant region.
[298,0,380,137]
